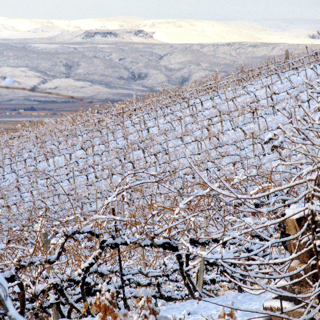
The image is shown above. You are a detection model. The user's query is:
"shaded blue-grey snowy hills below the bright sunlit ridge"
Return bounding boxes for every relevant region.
[0,41,316,105]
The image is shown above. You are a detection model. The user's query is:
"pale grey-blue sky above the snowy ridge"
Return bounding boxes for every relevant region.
[0,0,320,21]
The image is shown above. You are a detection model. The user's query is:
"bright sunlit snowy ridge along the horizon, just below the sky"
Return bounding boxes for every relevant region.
[0,17,320,44]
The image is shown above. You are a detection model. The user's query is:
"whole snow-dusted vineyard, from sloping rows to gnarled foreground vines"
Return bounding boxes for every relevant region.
[0,48,320,320]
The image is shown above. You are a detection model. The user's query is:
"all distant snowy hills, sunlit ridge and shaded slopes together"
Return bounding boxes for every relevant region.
[0,18,320,105]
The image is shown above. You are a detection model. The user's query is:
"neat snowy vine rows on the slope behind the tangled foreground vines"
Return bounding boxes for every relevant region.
[0,52,319,213]
